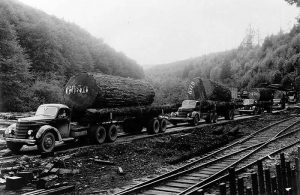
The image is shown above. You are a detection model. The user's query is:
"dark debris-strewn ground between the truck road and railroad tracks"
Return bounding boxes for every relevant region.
[0,114,289,194]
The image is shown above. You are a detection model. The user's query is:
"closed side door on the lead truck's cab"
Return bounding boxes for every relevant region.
[54,108,70,138]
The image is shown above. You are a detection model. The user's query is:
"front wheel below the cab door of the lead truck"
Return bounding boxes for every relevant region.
[37,131,55,152]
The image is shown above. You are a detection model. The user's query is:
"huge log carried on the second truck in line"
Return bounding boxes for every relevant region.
[188,77,231,102]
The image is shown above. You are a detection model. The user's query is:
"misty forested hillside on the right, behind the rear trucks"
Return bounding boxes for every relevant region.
[145,0,300,104]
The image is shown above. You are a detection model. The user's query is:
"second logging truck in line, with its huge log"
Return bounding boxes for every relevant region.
[168,77,236,125]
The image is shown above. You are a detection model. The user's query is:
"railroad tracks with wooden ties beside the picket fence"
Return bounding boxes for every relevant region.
[116,117,300,195]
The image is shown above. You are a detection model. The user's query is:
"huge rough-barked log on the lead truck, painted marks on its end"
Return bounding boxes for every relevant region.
[64,73,155,111]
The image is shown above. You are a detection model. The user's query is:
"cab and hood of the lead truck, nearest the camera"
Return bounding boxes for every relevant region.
[5,104,75,152]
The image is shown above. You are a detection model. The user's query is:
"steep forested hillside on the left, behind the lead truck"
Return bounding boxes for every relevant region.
[0,0,144,111]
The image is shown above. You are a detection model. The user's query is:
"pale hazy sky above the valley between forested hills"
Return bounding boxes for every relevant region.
[20,0,299,65]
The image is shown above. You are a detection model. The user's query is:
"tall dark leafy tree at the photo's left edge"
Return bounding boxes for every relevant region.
[0,16,31,111]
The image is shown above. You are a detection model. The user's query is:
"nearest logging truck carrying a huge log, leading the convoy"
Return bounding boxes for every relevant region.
[5,73,174,152]
